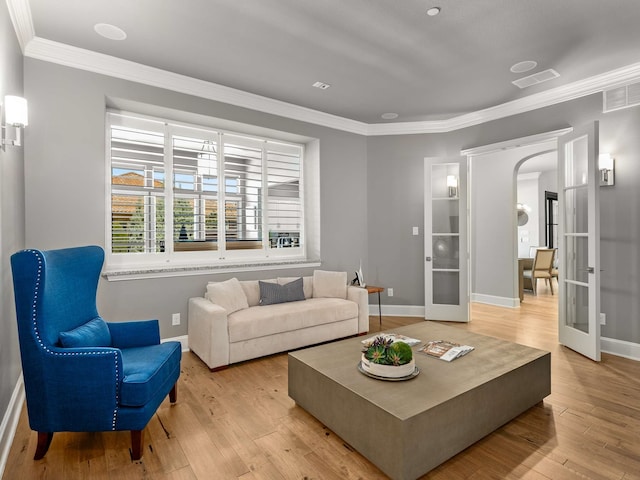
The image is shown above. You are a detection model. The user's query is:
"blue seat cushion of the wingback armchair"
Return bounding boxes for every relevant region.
[119,342,182,407]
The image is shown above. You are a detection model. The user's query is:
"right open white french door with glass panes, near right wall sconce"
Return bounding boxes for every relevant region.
[558,122,600,361]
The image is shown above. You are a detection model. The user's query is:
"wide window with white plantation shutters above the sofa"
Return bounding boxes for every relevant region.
[107,112,306,272]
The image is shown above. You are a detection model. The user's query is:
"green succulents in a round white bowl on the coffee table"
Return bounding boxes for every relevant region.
[361,336,416,378]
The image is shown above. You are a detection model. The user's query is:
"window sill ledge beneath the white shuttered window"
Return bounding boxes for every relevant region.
[102,260,322,282]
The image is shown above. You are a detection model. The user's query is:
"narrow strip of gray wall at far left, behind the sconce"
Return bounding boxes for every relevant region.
[0,2,29,438]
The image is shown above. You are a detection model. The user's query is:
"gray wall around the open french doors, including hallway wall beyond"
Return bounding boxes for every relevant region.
[365,94,640,343]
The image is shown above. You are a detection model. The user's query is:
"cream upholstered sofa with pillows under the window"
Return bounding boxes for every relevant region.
[188,270,369,370]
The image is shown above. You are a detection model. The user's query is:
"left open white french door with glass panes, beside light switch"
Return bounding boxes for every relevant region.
[424,157,469,322]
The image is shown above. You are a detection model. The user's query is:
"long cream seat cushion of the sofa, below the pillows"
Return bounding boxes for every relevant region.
[228,298,358,343]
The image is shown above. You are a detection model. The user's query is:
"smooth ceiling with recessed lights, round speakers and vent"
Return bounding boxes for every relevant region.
[7,0,640,130]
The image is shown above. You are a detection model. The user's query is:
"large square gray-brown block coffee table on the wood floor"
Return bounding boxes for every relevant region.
[289,321,551,480]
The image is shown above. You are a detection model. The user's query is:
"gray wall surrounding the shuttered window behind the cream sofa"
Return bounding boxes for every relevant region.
[25,58,367,338]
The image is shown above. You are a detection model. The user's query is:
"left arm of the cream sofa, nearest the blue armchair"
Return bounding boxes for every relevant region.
[188,297,229,369]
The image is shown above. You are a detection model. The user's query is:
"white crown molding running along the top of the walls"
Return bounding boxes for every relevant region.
[11,0,640,136]
